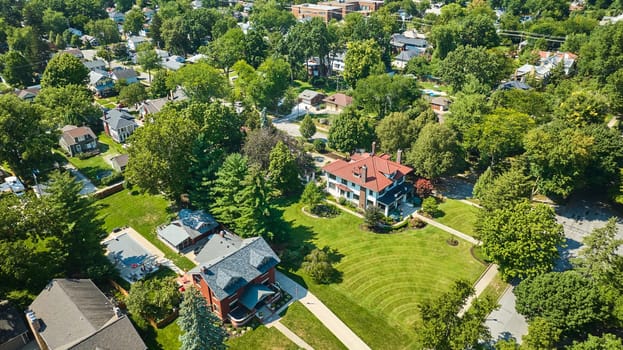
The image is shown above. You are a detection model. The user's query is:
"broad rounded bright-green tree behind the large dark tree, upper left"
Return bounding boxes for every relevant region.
[168,62,228,102]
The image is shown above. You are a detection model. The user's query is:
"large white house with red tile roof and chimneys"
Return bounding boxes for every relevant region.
[322,143,413,216]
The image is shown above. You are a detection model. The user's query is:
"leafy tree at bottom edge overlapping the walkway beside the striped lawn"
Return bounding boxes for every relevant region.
[417,280,495,350]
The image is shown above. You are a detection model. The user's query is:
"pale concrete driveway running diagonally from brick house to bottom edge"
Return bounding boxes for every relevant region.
[276,271,374,350]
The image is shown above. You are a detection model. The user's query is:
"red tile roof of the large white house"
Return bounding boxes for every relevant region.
[322,153,413,192]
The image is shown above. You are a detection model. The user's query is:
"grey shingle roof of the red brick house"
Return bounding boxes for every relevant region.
[190,237,280,300]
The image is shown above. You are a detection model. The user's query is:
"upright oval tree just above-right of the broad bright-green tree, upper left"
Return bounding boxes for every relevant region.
[206,26,245,80]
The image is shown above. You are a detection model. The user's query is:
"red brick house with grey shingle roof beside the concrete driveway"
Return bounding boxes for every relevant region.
[187,234,281,327]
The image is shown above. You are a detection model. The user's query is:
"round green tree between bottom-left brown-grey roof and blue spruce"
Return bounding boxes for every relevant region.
[126,278,181,325]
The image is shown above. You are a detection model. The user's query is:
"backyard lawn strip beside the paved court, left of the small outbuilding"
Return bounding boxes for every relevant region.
[98,190,195,270]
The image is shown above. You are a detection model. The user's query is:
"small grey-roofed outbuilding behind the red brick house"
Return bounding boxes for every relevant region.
[156,209,219,252]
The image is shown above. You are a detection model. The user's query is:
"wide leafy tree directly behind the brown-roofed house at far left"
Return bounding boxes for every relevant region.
[35,85,102,130]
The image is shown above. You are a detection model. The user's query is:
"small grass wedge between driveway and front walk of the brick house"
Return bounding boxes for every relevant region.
[281,302,346,350]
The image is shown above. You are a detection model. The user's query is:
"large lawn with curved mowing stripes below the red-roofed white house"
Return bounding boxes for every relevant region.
[284,203,484,349]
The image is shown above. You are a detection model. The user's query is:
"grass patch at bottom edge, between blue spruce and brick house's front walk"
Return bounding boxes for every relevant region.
[227,326,298,350]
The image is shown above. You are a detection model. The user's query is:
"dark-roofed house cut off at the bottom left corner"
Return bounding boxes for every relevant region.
[0,300,30,350]
